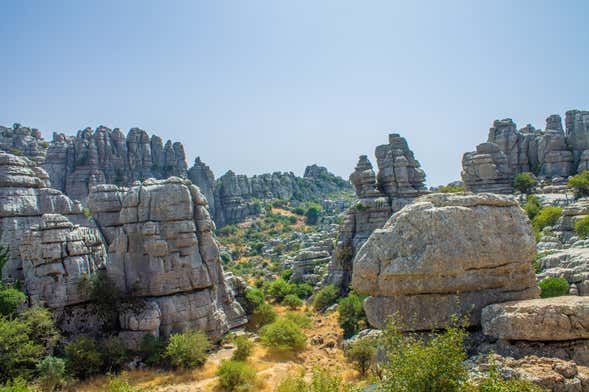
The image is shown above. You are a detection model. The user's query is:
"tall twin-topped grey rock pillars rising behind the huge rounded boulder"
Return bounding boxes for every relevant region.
[324,133,428,291]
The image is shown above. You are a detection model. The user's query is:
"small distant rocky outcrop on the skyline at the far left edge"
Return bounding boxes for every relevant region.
[0,124,48,164]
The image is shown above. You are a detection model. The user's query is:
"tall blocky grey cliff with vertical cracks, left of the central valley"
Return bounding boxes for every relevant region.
[89,177,247,342]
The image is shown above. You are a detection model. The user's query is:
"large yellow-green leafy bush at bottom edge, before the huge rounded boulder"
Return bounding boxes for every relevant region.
[381,318,468,392]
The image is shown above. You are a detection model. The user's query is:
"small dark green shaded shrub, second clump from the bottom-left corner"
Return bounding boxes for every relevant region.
[64,336,104,379]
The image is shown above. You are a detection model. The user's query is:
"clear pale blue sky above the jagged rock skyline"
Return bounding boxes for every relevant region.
[0,0,589,185]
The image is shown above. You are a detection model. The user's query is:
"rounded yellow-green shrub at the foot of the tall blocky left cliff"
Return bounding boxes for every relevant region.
[164,331,211,369]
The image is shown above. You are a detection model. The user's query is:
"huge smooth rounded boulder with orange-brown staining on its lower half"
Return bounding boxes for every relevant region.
[352,193,539,330]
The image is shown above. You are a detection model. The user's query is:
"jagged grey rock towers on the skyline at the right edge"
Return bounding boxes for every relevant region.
[462,110,589,193]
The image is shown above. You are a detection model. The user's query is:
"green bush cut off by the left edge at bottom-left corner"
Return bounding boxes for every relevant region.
[0,316,45,383]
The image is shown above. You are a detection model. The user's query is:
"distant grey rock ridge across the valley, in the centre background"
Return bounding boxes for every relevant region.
[211,165,350,227]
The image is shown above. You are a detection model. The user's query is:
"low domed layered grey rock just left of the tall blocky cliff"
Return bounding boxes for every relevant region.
[20,214,108,309]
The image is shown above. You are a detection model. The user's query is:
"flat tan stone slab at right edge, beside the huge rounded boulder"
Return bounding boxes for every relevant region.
[481,296,589,341]
